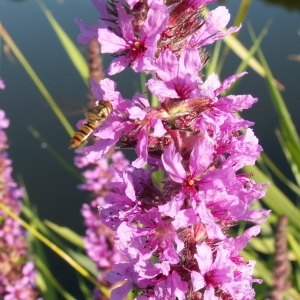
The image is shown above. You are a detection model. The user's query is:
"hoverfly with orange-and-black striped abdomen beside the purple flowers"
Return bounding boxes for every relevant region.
[69,101,113,149]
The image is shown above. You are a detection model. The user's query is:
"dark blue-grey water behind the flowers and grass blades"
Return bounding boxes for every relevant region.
[0,0,300,294]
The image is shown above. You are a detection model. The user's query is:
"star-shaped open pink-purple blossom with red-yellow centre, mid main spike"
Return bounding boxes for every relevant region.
[160,140,235,232]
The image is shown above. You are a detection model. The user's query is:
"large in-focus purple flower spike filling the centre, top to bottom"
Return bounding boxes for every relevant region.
[77,0,269,300]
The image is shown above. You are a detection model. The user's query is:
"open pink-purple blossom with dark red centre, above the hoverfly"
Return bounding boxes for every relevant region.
[98,3,168,75]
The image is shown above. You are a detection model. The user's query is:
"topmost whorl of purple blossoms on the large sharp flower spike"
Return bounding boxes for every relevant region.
[76,0,239,75]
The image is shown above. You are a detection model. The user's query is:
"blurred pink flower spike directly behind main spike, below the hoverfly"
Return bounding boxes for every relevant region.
[75,151,129,280]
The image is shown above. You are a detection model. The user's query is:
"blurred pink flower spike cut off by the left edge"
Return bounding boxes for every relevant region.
[0,110,38,300]
